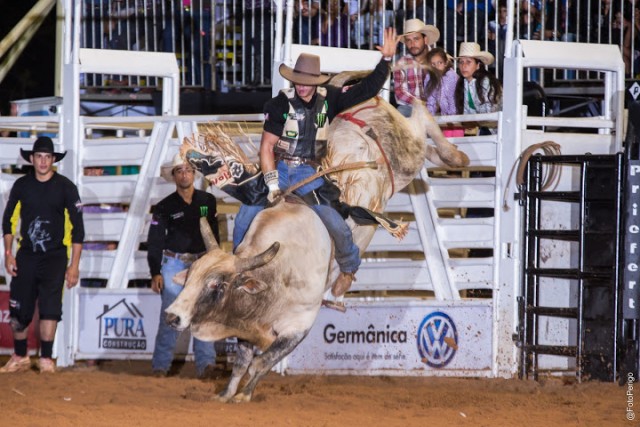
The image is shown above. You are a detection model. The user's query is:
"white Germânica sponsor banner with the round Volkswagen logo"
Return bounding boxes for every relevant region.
[287,304,493,371]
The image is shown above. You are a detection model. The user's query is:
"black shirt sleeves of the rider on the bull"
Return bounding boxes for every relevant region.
[264,59,390,136]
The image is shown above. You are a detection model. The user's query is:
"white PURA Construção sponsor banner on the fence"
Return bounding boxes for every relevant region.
[78,290,160,355]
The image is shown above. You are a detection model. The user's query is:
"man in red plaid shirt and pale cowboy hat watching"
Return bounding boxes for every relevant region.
[393,19,440,117]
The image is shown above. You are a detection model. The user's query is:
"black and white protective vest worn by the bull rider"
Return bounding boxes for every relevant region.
[273,87,329,160]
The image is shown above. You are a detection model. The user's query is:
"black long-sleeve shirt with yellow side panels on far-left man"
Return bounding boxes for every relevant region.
[2,172,84,253]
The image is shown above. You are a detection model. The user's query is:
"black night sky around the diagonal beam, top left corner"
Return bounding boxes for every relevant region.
[0,0,56,116]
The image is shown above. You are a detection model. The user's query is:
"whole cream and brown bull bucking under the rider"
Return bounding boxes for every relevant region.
[166,75,469,402]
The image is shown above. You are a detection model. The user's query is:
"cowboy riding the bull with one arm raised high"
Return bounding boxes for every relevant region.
[233,28,396,311]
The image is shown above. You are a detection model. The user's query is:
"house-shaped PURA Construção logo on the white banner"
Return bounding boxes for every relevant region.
[96,298,147,350]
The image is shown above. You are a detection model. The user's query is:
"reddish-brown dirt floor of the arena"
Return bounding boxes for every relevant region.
[0,360,640,427]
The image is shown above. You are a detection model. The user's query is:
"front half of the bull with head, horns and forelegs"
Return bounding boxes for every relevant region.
[166,202,332,402]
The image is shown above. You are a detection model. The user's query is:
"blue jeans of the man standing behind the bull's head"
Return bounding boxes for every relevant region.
[151,256,216,376]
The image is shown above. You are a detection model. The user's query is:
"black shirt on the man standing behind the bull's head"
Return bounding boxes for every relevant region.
[147,190,220,276]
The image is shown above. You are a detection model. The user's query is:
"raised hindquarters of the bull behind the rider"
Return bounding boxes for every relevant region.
[323,89,469,253]
